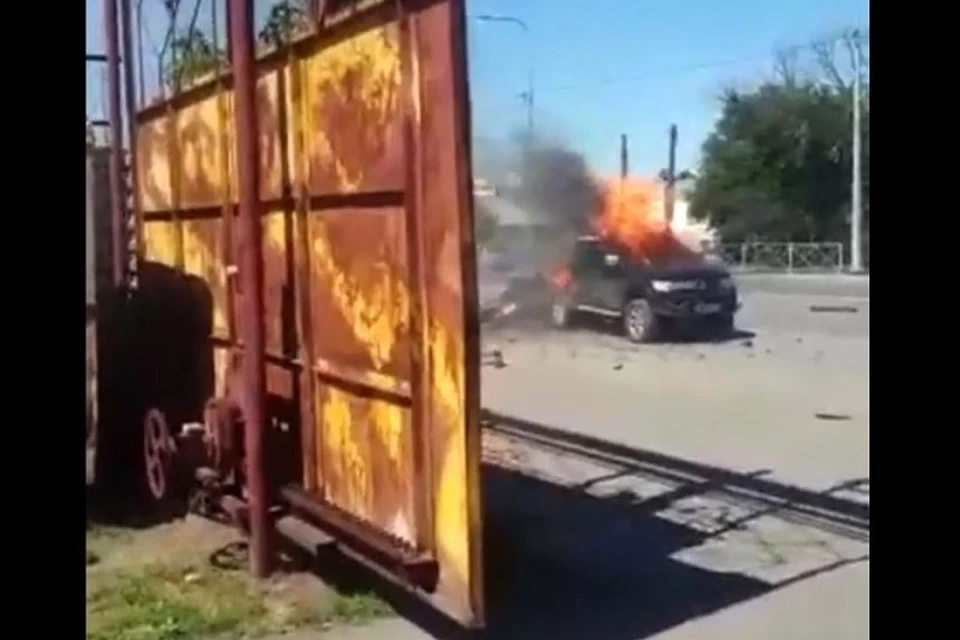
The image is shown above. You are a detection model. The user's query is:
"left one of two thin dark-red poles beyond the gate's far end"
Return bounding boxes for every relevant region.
[103,0,125,287]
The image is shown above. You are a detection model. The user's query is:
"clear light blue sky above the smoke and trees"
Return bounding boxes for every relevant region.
[87,0,869,174]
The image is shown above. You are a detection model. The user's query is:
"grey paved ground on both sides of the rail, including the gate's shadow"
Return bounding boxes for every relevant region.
[316,275,870,640]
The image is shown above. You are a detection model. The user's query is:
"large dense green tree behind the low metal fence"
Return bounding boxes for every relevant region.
[691,80,870,242]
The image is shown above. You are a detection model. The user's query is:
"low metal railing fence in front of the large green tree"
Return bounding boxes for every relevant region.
[721,242,845,273]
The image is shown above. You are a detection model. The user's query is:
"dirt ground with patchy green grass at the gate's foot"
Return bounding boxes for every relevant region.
[87,516,391,640]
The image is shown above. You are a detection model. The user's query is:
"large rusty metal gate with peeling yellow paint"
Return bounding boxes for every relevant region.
[136,0,483,624]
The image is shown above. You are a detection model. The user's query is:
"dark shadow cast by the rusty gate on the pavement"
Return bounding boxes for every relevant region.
[352,465,866,640]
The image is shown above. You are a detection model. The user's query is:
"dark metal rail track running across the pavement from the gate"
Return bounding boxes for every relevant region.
[483,410,870,543]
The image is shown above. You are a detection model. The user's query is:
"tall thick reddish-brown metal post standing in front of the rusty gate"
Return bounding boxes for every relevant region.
[228,0,270,577]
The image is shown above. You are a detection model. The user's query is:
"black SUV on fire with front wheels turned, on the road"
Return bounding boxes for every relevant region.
[551,236,739,343]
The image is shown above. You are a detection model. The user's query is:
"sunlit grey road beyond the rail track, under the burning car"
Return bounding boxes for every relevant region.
[482,279,870,496]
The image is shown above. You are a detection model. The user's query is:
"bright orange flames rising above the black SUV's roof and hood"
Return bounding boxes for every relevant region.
[592,178,696,262]
